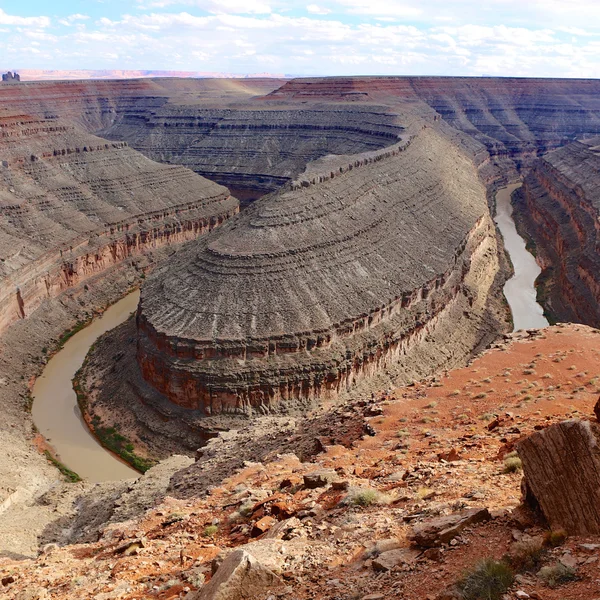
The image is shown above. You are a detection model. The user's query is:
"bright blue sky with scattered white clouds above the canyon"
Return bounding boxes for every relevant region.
[0,0,600,78]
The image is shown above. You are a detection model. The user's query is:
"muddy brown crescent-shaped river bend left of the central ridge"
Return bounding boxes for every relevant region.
[32,291,140,482]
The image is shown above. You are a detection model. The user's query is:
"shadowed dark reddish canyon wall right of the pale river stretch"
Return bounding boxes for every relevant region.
[517,137,600,327]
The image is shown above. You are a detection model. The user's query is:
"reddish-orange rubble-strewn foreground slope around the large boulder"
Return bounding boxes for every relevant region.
[0,325,600,600]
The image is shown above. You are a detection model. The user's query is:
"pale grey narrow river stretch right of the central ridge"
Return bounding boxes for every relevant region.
[495,183,548,331]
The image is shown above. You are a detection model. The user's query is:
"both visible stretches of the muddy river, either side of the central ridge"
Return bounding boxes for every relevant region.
[32,184,548,482]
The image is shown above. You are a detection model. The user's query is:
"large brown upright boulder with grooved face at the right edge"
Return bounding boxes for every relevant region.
[517,420,600,535]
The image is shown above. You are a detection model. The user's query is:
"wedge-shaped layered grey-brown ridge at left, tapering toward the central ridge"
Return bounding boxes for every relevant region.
[0,110,238,331]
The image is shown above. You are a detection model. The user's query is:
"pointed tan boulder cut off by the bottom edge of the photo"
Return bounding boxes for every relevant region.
[186,550,281,600]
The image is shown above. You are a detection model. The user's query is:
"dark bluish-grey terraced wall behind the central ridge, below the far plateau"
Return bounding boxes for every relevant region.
[100,102,404,200]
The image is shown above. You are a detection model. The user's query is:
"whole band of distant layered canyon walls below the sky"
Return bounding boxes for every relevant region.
[0,77,600,202]
